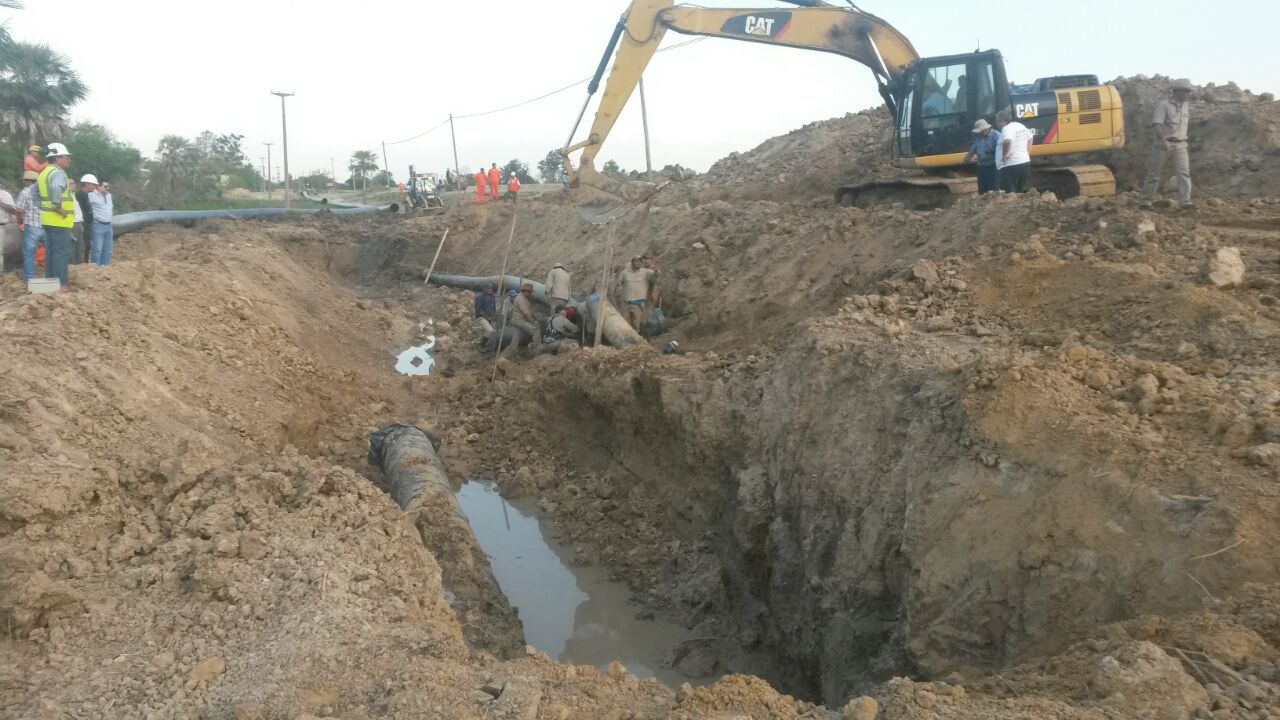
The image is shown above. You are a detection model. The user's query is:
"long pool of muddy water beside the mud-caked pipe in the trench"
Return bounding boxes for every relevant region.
[458,482,695,687]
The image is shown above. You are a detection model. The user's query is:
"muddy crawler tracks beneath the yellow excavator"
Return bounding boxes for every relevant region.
[836,165,1116,210]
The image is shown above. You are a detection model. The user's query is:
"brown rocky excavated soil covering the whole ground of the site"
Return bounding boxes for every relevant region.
[0,73,1280,720]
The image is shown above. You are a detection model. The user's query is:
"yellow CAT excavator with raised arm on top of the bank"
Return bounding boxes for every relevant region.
[561,0,1124,209]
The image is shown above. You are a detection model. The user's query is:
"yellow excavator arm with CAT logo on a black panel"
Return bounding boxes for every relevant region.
[561,0,919,202]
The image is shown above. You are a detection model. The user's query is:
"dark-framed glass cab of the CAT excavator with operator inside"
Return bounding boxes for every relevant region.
[893,50,1010,167]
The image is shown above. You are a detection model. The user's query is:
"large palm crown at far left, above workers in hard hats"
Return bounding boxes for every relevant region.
[0,42,88,143]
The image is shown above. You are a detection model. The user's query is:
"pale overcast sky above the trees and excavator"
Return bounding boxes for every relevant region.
[0,0,1280,177]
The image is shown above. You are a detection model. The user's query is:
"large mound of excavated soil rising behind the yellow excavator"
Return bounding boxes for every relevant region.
[690,77,1280,200]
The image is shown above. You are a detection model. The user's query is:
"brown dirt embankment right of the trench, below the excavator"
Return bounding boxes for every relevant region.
[410,184,1280,702]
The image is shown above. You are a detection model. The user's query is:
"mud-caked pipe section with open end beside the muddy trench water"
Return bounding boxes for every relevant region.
[369,425,525,657]
